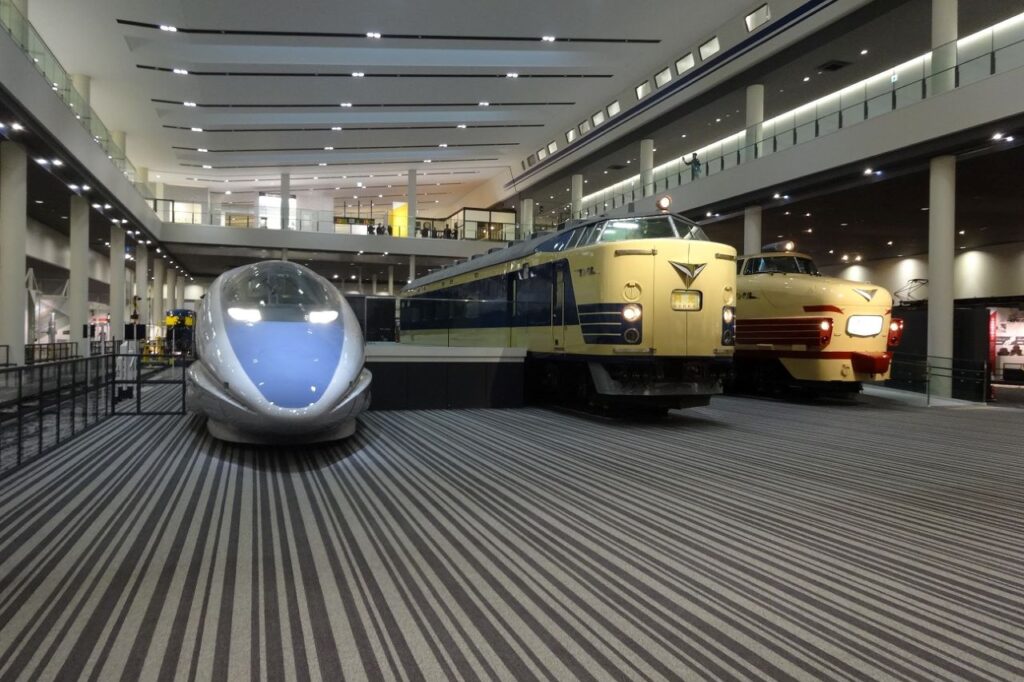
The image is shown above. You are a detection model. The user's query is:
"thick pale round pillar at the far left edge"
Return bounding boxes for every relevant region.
[0,142,26,365]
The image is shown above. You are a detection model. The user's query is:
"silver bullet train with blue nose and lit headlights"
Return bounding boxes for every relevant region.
[186,260,372,443]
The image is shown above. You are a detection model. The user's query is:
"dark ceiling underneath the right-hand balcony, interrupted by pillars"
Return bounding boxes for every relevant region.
[690,141,1024,265]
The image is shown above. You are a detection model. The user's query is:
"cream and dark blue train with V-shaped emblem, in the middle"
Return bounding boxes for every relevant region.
[400,214,736,410]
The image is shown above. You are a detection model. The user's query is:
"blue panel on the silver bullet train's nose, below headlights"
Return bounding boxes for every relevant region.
[225,321,344,409]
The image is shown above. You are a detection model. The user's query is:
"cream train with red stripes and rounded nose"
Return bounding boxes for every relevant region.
[735,242,903,391]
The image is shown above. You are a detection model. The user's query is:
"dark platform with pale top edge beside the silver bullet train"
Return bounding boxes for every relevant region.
[366,343,526,410]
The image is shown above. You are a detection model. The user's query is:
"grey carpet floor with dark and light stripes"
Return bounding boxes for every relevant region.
[0,397,1024,681]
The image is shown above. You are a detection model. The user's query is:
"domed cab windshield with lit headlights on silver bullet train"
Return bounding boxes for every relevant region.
[221,262,341,324]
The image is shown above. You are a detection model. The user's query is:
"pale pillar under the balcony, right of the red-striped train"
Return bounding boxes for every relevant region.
[928,156,956,397]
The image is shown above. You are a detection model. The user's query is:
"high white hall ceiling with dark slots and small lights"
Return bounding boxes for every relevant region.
[29,0,751,215]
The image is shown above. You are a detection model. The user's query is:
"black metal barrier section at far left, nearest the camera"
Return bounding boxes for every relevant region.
[0,355,114,476]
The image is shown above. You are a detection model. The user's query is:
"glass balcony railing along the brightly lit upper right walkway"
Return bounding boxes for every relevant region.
[582,14,1024,217]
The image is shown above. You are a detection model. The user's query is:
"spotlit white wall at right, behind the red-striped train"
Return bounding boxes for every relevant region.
[821,242,1024,299]
